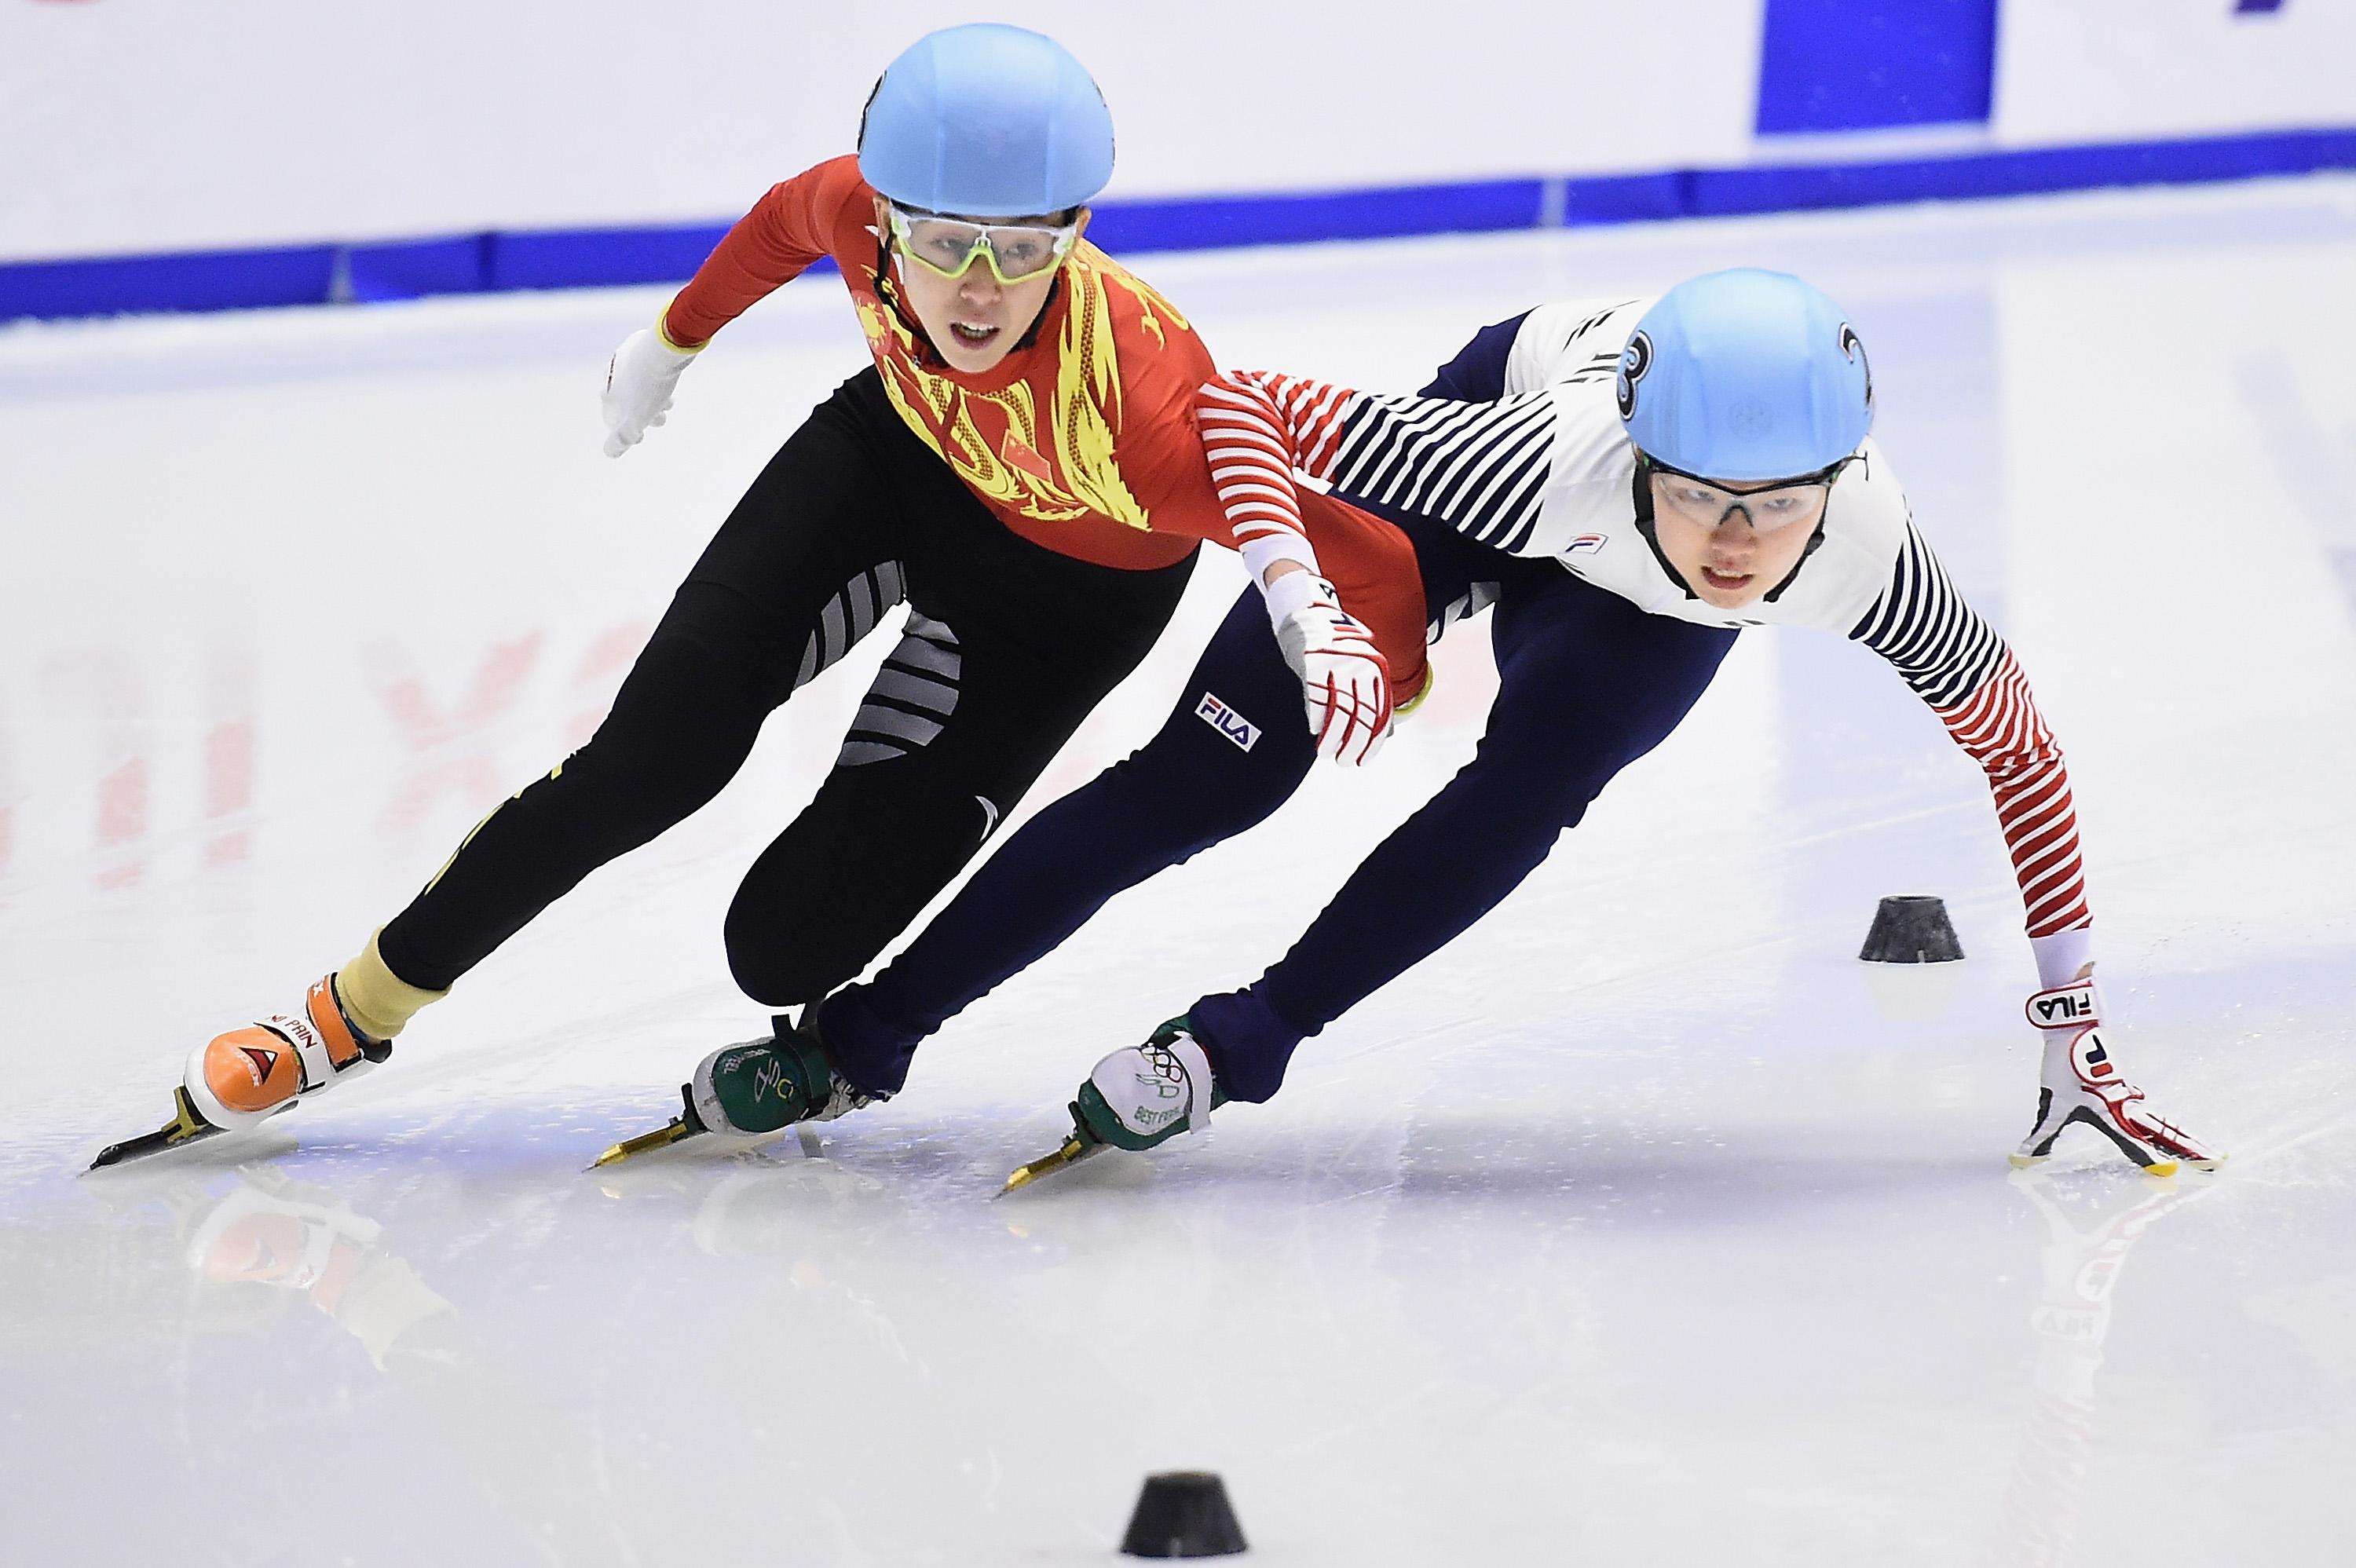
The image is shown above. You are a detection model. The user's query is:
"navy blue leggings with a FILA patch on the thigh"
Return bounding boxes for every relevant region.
[820,323,1736,1099]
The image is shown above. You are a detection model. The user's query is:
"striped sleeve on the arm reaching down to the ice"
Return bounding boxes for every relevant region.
[1849,523,2092,937]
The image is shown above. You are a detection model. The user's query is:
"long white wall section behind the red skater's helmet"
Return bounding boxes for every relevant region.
[0,0,1760,259]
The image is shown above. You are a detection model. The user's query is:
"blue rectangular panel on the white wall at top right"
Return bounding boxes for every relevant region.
[1758,0,1996,137]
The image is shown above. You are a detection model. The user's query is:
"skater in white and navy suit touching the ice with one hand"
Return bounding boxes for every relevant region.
[820,271,2217,1175]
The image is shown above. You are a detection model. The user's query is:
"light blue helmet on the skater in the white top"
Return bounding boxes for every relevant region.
[1619,266,1873,481]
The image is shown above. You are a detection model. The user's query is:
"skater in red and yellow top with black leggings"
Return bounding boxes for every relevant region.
[101,26,1425,1153]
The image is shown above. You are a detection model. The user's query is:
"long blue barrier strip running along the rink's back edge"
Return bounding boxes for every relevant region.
[0,127,2356,320]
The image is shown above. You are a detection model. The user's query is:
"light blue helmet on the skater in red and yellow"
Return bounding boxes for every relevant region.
[860,21,1112,217]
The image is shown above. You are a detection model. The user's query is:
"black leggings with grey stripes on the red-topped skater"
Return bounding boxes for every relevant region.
[379,370,1192,1007]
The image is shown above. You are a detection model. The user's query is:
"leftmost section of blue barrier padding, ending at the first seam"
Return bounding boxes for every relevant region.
[0,245,335,320]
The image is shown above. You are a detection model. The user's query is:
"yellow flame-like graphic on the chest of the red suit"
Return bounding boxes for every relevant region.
[860,243,1187,530]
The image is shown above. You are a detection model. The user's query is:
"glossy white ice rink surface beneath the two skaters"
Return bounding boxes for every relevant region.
[13,179,2356,1566]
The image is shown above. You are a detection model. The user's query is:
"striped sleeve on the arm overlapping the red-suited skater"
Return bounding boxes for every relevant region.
[1197,370,1555,554]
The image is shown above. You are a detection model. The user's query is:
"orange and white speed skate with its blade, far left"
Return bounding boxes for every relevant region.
[90,974,393,1170]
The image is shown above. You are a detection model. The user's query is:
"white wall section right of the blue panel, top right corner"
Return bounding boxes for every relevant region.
[1993,0,2356,144]
